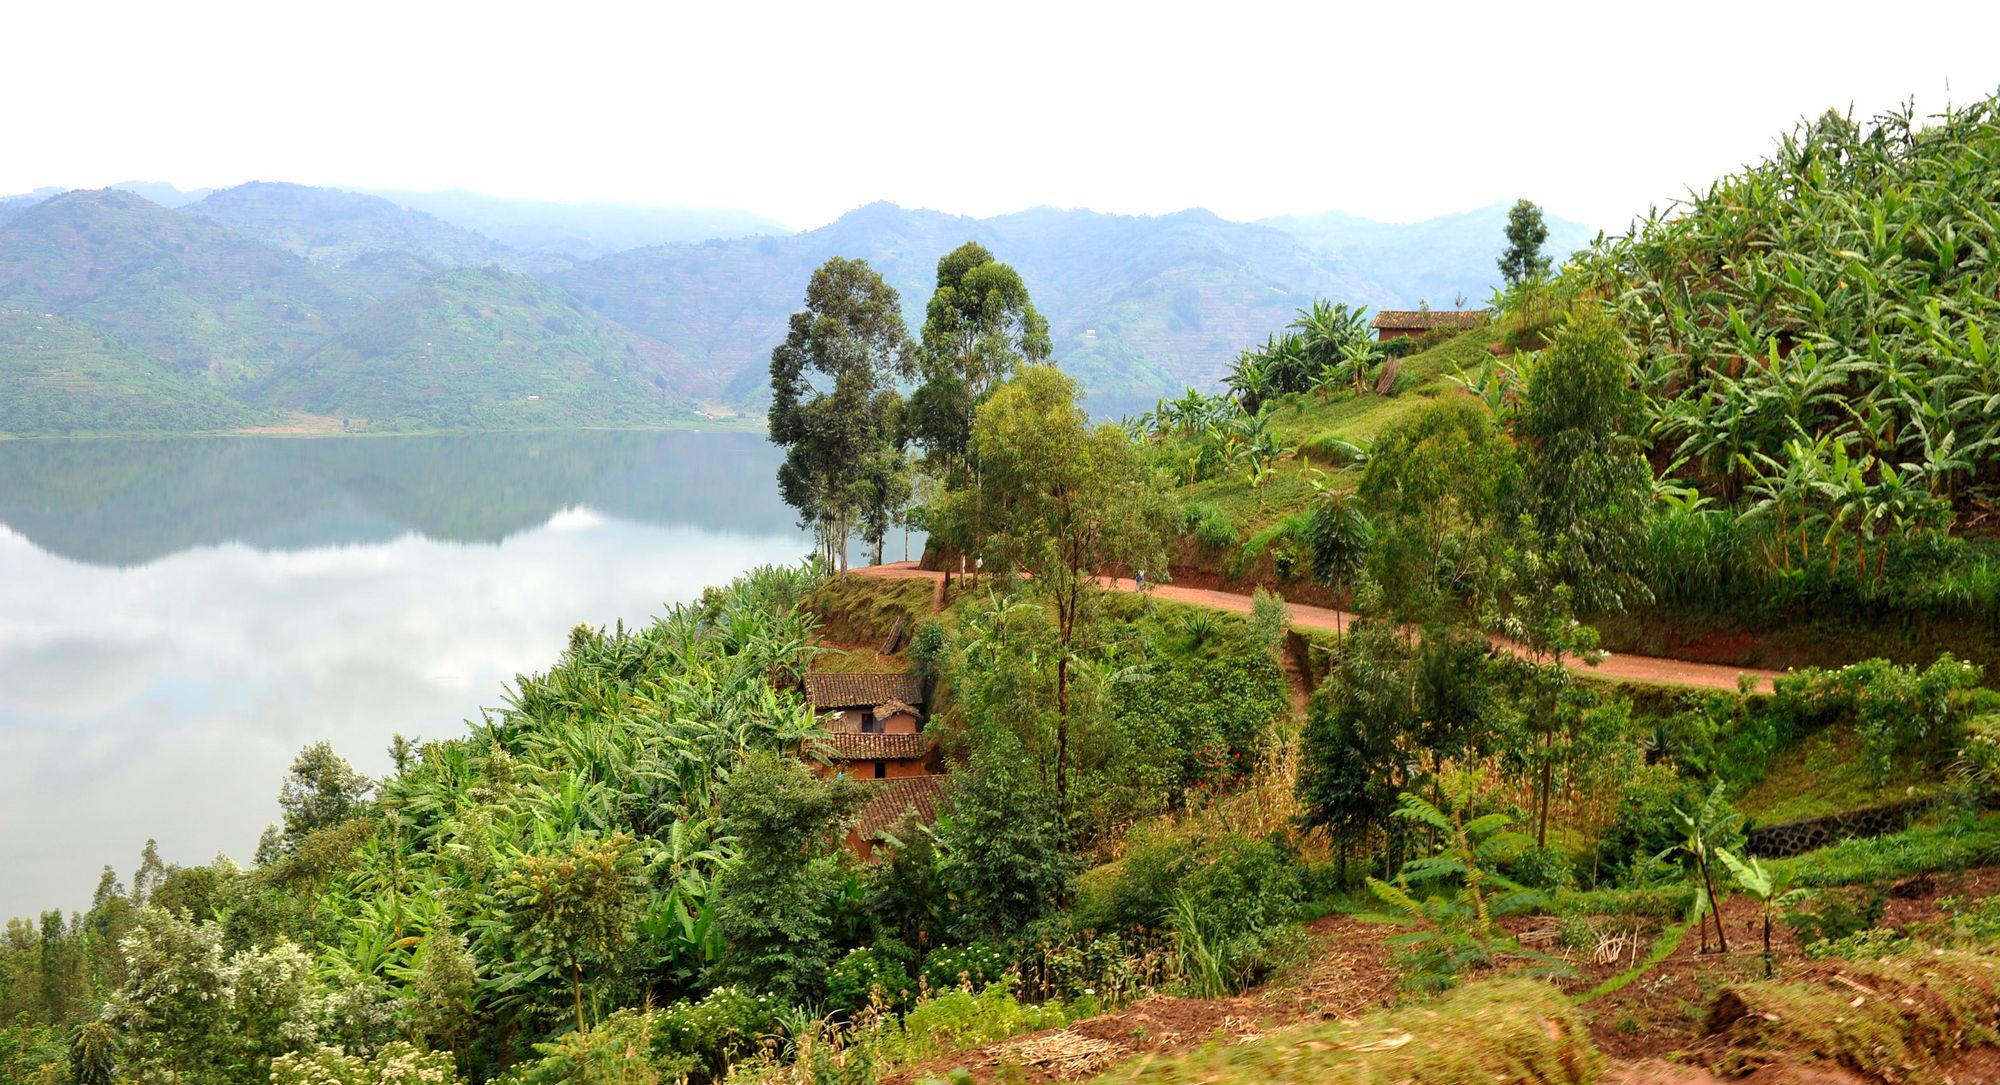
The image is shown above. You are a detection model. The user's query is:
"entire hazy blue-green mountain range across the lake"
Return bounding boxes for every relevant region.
[0,182,1590,434]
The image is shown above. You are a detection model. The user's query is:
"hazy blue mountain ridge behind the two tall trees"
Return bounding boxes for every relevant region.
[556,204,1392,412]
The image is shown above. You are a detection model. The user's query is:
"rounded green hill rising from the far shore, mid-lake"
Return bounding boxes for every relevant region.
[250,268,712,430]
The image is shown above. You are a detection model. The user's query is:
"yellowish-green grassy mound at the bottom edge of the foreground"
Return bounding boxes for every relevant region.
[1096,979,1602,1085]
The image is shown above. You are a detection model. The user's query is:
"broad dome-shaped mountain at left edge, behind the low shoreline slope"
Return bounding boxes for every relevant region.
[0,190,350,386]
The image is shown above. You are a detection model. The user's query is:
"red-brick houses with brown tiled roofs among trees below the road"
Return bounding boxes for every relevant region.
[806,673,944,859]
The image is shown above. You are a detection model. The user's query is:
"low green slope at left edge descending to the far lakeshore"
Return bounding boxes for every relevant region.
[0,308,266,436]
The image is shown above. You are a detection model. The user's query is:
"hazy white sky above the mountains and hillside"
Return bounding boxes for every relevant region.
[11,0,2000,226]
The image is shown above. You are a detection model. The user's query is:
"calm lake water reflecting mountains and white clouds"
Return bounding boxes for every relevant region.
[0,432,900,917]
